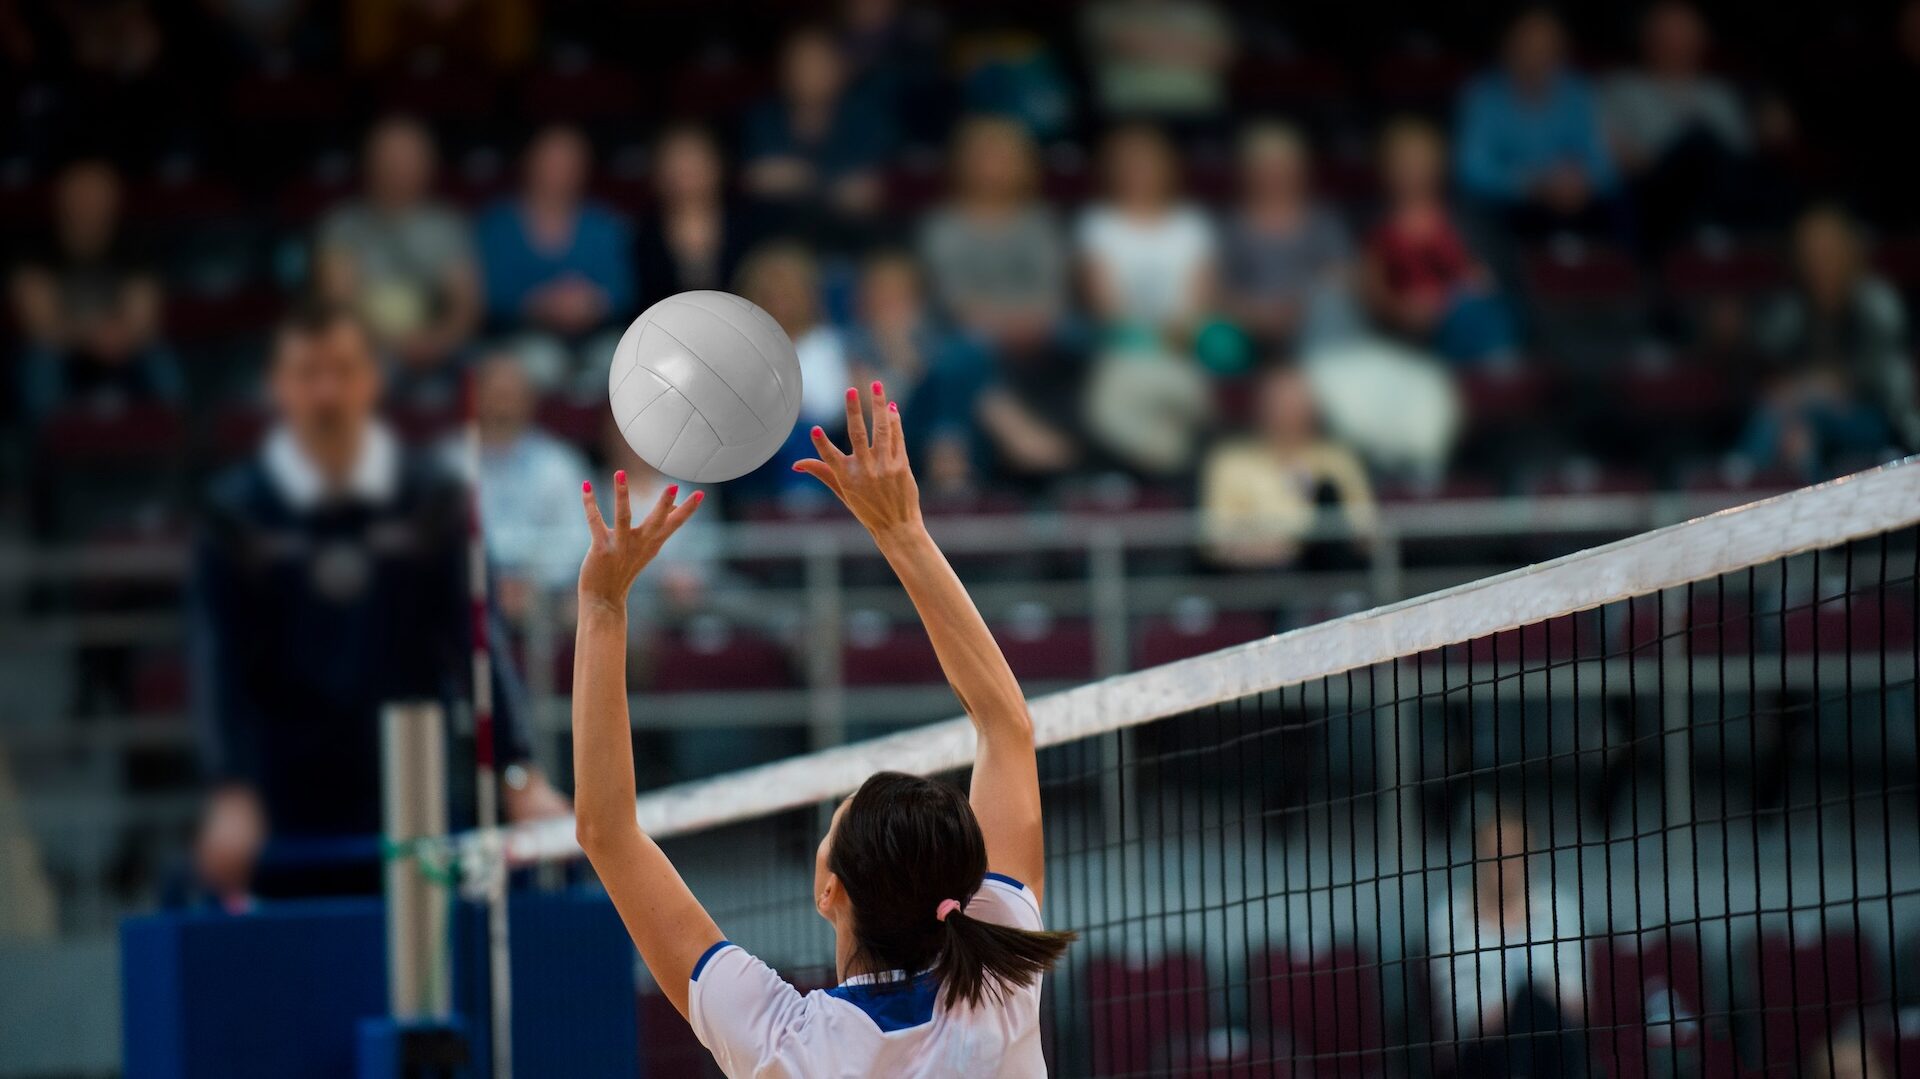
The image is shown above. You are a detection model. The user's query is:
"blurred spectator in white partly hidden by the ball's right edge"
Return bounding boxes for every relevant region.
[737,242,852,441]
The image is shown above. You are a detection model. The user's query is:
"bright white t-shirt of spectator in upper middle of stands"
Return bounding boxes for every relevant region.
[1077,205,1219,328]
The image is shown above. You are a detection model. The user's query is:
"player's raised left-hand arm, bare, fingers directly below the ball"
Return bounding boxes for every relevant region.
[574,472,722,1016]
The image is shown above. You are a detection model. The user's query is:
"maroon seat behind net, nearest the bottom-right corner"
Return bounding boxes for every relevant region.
[1747,929,1880,1075]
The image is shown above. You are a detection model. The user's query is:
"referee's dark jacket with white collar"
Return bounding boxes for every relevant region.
[190,428,526,841]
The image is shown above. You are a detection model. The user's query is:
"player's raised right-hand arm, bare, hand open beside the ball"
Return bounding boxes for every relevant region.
[793,382,1046,897]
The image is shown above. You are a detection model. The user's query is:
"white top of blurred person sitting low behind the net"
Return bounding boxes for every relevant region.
[1427,883,1586,1041]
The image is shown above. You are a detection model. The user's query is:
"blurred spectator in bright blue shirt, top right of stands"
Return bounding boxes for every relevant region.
[1457,8,1619,236]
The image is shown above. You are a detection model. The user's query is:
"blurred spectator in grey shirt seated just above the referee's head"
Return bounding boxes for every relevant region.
[315,117,480,399]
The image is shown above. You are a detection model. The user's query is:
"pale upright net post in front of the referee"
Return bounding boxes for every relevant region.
[380,701,453,1023]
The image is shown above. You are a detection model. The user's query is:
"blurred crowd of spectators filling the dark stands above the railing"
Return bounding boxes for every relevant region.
[0,0,1920,584]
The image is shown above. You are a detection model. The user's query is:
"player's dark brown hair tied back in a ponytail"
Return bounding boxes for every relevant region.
[828,772,1075,1004]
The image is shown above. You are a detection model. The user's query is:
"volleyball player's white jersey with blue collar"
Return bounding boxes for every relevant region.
[687,874,1046,1079]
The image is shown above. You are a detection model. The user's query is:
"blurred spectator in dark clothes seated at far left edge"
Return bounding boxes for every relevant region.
[12,161,184,420]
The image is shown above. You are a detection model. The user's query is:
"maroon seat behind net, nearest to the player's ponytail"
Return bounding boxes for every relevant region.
[1087,952,1208,1075]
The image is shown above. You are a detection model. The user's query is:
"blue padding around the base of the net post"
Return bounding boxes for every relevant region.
[121,891,639,1079]
